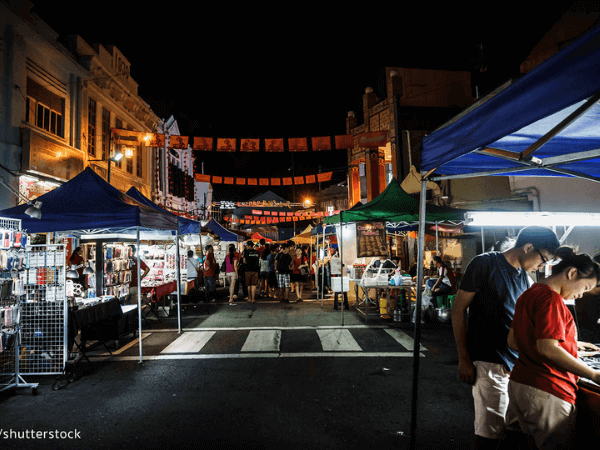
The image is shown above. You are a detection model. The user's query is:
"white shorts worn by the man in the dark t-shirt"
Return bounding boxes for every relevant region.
[473,361,510,439]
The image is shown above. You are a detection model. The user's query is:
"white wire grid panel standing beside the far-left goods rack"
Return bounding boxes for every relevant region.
[19,244,67,375]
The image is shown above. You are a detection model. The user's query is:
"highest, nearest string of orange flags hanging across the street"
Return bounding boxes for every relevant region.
[111,128,388,152]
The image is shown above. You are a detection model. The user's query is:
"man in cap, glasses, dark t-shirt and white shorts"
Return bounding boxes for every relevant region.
[452,226,559,449]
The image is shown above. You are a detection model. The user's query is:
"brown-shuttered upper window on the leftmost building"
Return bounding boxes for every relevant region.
[25,78,65,138]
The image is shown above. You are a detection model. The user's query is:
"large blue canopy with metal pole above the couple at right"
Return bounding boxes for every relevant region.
[410,26,600,448]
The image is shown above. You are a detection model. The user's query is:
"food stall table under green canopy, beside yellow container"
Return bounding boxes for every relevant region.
[354,280,415,323]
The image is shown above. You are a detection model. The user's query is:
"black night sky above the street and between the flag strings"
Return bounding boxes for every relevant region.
[34,0,573,201]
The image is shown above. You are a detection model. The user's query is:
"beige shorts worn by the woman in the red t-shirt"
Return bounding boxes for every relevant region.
[506,381,577,450]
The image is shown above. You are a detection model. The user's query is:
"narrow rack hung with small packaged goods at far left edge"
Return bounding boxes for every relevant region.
[0,218,38,394]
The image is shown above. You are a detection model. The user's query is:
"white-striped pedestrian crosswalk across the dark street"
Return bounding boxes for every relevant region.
[90,325,427,360]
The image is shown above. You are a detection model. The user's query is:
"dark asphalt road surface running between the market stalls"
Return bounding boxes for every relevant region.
[0,301,473,450]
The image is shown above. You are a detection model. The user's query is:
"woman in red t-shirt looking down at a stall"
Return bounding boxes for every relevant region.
[506,247,600,449]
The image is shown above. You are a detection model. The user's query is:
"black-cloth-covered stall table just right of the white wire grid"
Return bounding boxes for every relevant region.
[69,298,138,354]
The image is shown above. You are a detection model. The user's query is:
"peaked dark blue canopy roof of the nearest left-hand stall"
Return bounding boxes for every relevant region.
[0,168,177,233]
